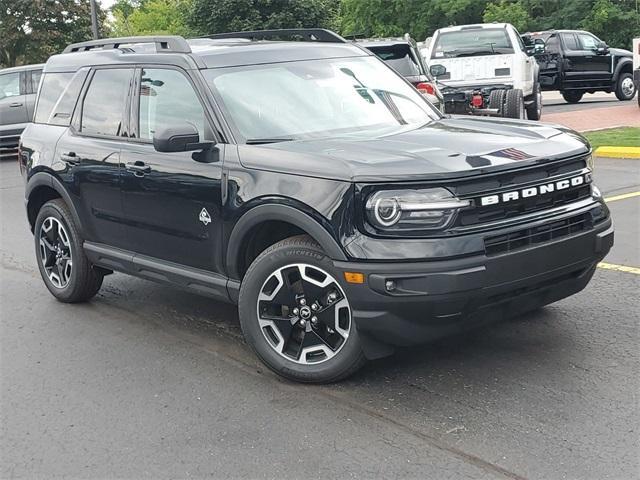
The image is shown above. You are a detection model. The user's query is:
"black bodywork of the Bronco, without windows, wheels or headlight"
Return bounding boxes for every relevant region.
[20,32,613,357]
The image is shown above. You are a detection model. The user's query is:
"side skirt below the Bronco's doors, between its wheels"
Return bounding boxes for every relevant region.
[84,242,240,303]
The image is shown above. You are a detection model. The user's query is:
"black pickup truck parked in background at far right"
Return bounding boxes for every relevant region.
[523,30,636,103]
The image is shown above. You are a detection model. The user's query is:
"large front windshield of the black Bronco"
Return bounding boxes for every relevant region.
[204,57,439,143]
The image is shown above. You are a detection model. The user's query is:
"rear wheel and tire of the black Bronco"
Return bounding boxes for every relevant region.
[33,199,104,303]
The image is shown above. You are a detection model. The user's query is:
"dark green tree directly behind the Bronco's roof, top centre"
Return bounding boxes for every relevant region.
[189,0,340,35]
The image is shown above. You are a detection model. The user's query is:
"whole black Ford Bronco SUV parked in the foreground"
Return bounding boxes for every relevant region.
[19,30,613,382]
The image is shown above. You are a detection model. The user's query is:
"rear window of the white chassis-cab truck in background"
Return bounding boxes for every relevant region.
[431,28,513,58]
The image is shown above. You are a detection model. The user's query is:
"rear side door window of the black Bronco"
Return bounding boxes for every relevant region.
[80,68,133,137]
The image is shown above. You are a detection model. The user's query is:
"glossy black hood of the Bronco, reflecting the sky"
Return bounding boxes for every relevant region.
[238,116,589,182]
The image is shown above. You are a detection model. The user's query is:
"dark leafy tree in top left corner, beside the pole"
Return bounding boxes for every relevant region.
[0,0,105,67]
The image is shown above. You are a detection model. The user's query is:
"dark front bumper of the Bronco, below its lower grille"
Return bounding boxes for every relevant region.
[335,218,613,350]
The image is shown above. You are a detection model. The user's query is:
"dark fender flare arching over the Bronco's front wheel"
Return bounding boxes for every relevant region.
[226,204,347,278]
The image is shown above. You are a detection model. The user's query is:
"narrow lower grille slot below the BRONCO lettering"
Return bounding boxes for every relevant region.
[484,213,593,256]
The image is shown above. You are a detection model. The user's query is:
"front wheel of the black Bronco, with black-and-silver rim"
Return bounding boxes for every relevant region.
[238,235,365,383]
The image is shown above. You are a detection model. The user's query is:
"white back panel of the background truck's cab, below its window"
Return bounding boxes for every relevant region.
[430,54,515,85]
